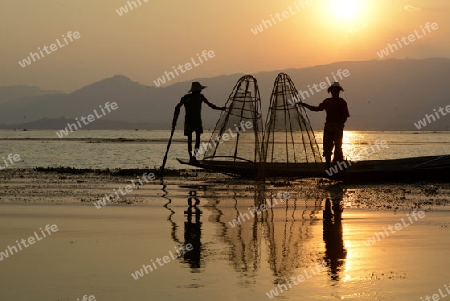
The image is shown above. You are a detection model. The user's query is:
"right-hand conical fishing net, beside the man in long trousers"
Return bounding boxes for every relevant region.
[262,73,322,168]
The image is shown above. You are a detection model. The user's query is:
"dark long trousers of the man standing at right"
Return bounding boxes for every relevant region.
[323,124,344,166]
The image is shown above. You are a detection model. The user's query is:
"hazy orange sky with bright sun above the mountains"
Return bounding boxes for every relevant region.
[0,0,450,92]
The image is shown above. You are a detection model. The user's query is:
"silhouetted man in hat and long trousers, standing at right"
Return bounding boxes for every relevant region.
[301,82,350,168]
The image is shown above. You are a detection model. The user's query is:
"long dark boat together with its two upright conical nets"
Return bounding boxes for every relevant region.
[177,73,450,183]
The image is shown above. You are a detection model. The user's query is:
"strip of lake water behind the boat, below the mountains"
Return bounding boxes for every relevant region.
[0,130,450,169]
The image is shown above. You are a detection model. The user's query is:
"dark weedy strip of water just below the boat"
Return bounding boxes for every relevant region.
[0,167,450,213]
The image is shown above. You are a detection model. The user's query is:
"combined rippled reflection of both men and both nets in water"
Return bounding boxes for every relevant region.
[163,183,347,286]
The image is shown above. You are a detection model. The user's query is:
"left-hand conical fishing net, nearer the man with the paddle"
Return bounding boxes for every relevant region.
[199,75,263,162]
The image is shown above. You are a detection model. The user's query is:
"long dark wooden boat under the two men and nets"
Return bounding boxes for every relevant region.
[177,155,450,184]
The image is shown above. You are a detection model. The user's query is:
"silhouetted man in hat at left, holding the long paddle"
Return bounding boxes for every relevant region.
[172,82,226,163]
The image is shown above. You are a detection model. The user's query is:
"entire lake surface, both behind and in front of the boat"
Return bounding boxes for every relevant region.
[0,131,450,301]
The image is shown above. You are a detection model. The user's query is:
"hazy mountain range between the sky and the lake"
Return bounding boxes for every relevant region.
[0,58,450,130]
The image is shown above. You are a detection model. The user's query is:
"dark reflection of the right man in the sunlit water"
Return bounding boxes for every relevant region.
[323,198,347,280]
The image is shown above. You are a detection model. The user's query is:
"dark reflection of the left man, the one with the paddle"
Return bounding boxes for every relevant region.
[184,192,202,269]
